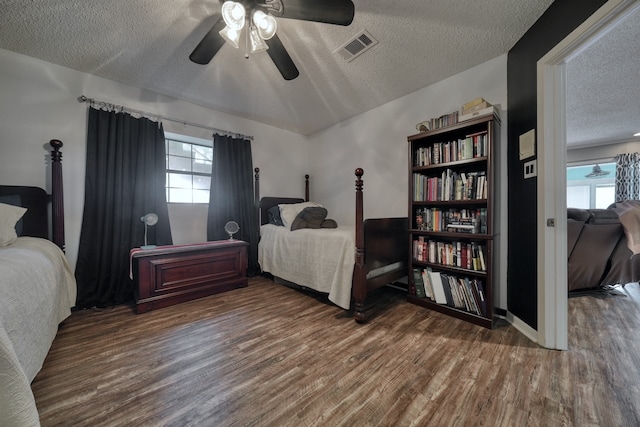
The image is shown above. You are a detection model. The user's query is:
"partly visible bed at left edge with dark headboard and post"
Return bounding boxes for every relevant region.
[0,141,76,426]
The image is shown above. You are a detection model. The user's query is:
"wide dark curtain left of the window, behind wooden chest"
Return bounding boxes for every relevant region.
[76,108,172,308]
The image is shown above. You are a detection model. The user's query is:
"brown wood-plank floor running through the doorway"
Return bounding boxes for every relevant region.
[33,278,640,427]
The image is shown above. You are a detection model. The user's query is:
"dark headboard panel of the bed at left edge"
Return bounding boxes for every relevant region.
[0,185,50,239]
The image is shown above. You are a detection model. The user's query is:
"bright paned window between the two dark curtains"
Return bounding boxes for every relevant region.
[165,132,213,203]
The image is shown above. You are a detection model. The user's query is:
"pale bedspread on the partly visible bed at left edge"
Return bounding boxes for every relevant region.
[0,237,77,425]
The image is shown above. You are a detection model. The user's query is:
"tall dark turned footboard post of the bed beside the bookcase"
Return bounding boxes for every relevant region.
[352,168,367,323]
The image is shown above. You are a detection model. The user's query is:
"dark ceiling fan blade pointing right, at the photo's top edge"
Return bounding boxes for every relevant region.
[264,0,355,26]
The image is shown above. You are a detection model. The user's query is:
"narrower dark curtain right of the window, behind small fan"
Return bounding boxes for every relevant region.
[207,134,258,276]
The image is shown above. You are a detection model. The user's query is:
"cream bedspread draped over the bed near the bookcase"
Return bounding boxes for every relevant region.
[258,224,356,310]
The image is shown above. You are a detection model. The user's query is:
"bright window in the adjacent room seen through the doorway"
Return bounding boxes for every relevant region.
[567,163,616,209]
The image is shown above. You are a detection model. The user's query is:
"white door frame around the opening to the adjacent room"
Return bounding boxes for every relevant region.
[537,0,640,350]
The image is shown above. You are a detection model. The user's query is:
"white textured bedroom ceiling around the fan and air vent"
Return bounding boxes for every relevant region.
[0,0,640,145]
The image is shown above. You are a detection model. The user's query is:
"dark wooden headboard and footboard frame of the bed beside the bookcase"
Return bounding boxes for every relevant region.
[254,168,409,323]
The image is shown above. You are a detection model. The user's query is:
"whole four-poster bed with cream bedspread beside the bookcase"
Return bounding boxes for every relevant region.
[255,168,408,323]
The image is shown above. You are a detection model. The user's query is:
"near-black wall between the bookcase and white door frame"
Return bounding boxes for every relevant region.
[507,0,606,329]
